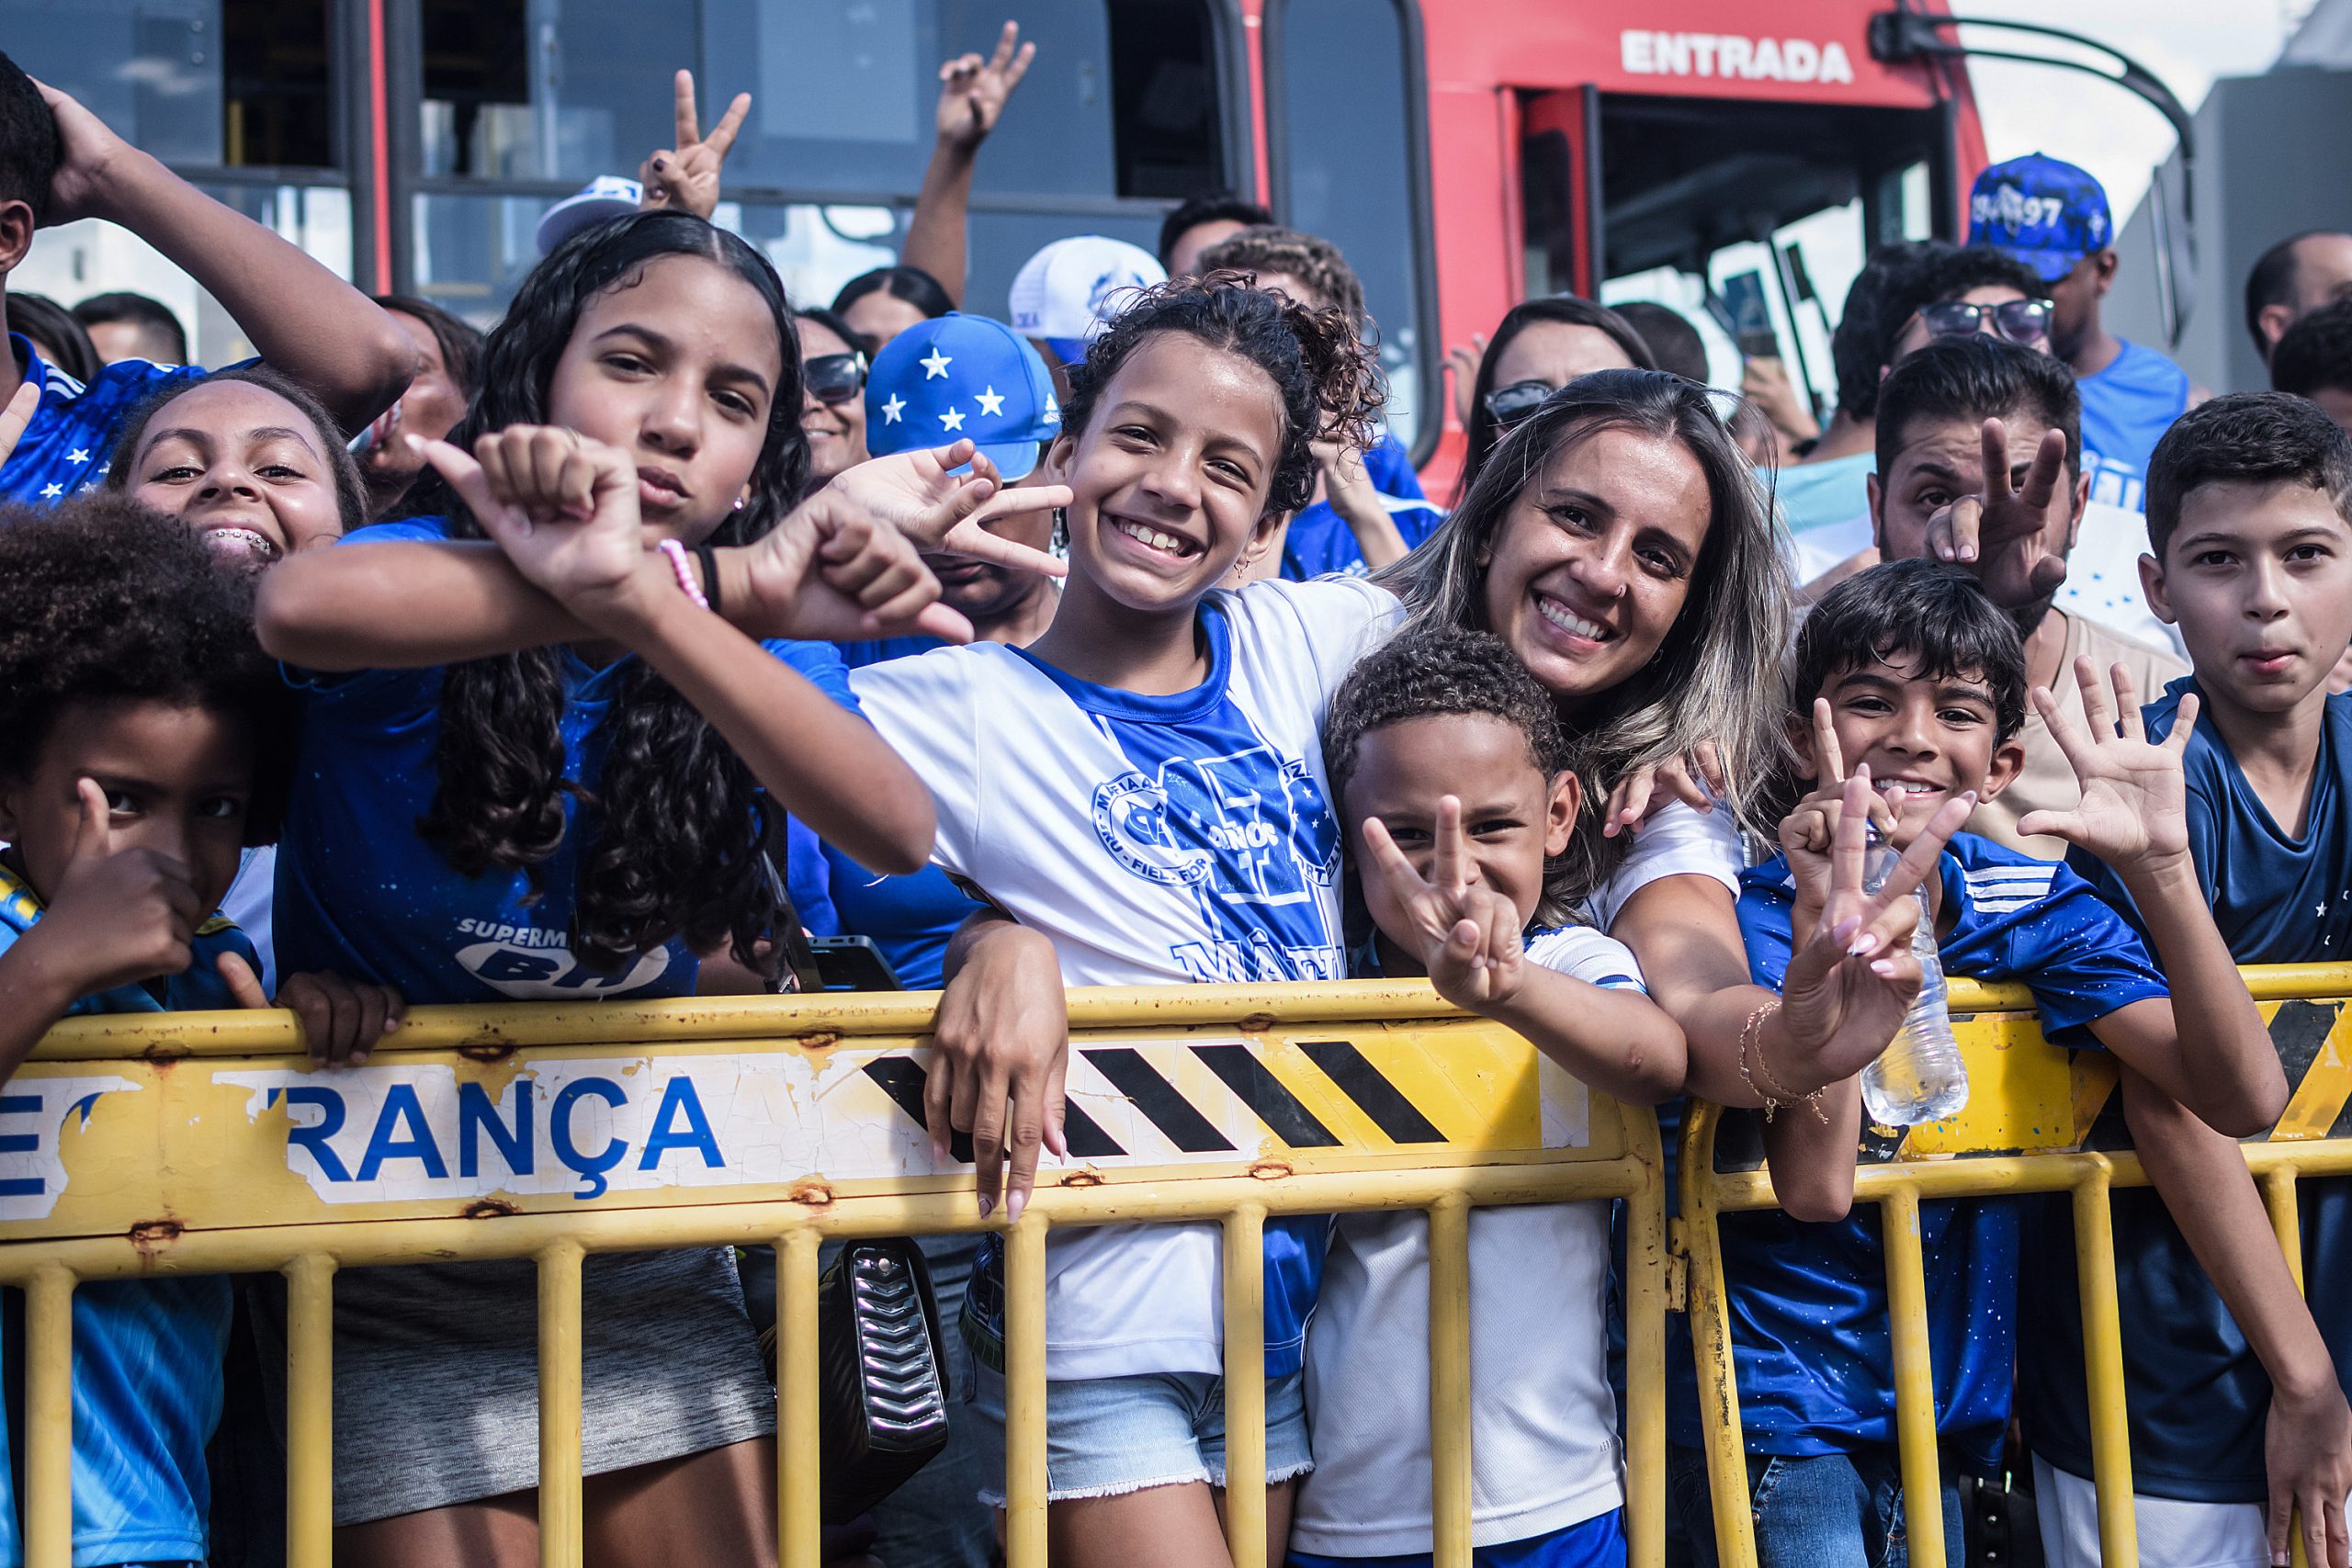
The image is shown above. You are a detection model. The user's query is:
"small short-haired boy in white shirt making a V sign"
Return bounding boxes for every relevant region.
[1289,627,1684,1568]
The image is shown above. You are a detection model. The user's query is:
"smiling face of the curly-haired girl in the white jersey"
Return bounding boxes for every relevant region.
[1046,332,1284,614]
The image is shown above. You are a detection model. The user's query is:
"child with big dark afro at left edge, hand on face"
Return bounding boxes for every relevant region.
[0,496,400,1568]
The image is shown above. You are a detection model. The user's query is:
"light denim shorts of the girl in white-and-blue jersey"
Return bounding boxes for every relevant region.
[971,1366,1315,1506]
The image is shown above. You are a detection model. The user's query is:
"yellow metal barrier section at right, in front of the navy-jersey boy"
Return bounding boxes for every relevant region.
[1677,964,2352,1568]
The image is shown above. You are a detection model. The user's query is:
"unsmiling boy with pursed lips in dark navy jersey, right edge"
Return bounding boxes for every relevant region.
[2018,392,2352,1568]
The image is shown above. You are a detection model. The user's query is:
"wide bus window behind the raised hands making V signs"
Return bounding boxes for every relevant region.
[416,0,1247,317]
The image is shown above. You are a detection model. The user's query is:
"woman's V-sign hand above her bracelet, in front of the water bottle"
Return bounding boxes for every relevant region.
[1759,766,1975,1086]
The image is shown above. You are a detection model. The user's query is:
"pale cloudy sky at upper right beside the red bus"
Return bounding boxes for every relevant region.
[1952,0,2312,226]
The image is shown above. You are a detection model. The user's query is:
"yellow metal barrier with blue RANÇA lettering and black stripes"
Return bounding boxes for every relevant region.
[0,983,1668,1568]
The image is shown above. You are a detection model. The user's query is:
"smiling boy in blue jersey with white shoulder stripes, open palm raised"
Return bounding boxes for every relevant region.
[1668,559,2286,1568]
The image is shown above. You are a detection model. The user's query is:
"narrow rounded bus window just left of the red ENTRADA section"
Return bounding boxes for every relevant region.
[1265,0,1444,456]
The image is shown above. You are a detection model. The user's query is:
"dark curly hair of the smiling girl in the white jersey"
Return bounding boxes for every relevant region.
[1063,270,1385,513]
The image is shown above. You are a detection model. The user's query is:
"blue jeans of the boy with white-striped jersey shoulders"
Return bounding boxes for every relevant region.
[1665,1443,1962,1568]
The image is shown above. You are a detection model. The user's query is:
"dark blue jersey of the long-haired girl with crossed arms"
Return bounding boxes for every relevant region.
[276,517,856,1001]
